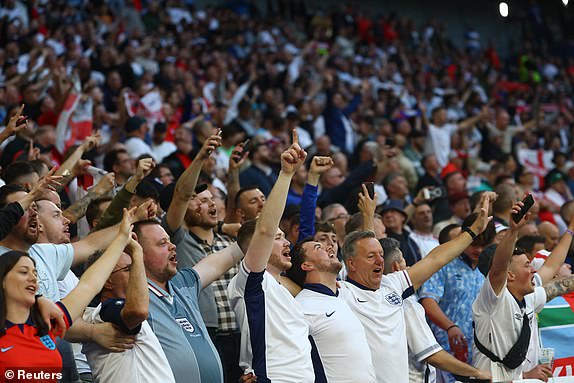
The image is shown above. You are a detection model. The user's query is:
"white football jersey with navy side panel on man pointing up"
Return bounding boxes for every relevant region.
[227,262,315,383]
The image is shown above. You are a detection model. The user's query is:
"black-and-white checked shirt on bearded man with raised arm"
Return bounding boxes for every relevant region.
[194,232,239,333]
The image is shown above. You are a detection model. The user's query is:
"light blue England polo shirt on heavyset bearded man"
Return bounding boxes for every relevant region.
[147,268,223,383]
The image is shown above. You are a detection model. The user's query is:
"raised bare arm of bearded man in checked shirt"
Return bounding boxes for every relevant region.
[166,135,221,232]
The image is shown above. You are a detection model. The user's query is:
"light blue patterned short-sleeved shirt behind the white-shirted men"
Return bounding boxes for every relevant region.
[419,255,484,360]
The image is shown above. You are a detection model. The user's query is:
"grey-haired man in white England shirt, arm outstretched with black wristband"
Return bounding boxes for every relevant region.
[340,194,496,383]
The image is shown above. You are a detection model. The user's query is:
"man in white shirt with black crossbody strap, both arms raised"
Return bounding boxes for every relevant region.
[472,201,572,381]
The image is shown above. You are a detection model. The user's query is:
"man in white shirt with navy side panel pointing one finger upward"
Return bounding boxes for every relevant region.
[228,131,315,383]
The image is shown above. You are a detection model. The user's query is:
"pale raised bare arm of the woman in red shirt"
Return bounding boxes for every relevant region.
[62,210,132,321]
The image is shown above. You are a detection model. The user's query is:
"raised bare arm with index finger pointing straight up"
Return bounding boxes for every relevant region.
[244,129,307,273]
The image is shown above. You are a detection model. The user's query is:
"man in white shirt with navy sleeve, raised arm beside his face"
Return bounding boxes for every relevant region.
[82,238,175,383]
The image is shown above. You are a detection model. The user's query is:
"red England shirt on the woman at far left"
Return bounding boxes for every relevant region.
[0,302,72,382]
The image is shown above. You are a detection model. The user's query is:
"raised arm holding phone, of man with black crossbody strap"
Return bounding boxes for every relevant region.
[488,201,530,295]
